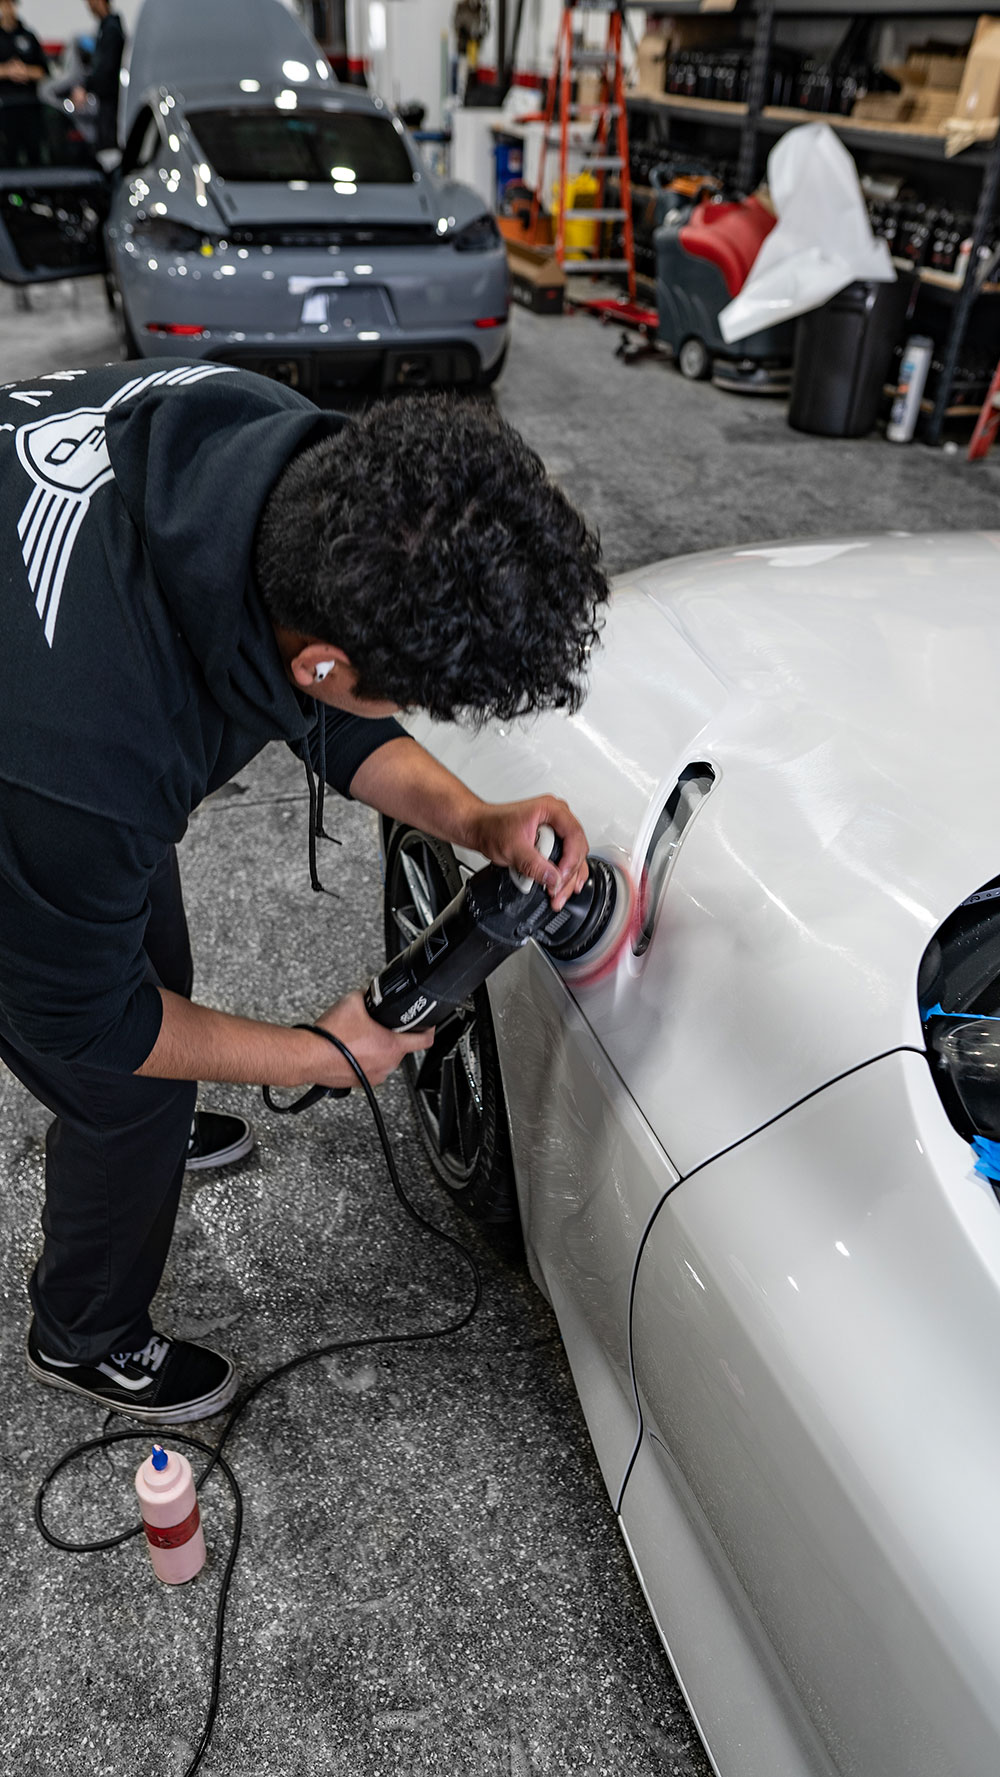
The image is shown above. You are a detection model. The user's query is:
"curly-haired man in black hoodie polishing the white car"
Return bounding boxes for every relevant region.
[0,359,607,1422]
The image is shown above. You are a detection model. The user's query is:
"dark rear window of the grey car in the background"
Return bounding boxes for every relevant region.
[188,108,414,185]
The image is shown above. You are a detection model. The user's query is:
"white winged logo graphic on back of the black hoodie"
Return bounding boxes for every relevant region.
[14,364,233,647]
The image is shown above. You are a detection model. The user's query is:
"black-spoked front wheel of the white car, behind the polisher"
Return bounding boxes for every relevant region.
[384,825,522,1256]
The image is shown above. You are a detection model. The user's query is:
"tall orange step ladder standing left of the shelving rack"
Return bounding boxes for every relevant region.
[529,0,636,300]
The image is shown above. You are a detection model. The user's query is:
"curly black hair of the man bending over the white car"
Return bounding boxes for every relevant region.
[254,394,609,721]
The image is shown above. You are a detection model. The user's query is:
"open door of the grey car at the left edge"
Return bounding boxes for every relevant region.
[0,105,110,284]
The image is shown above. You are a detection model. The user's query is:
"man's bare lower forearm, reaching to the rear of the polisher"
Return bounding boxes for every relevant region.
[135,988,328,1086]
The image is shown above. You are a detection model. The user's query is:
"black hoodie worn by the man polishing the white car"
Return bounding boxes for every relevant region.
[0,359,403,1073]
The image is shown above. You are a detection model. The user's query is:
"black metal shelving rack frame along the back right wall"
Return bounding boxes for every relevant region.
[629,0,1000,444]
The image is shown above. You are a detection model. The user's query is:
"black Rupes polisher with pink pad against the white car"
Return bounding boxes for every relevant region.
[364,826,636,1031]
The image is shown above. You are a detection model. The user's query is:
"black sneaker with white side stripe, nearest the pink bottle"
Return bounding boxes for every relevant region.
[28,1320,238,1425]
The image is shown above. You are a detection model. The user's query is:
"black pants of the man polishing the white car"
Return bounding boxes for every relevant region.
[0,851,195,1363]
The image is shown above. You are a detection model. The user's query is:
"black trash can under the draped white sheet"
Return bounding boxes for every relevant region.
[789,272,915,439]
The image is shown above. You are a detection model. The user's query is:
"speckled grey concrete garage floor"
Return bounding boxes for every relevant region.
[0,283,1000,1777]
